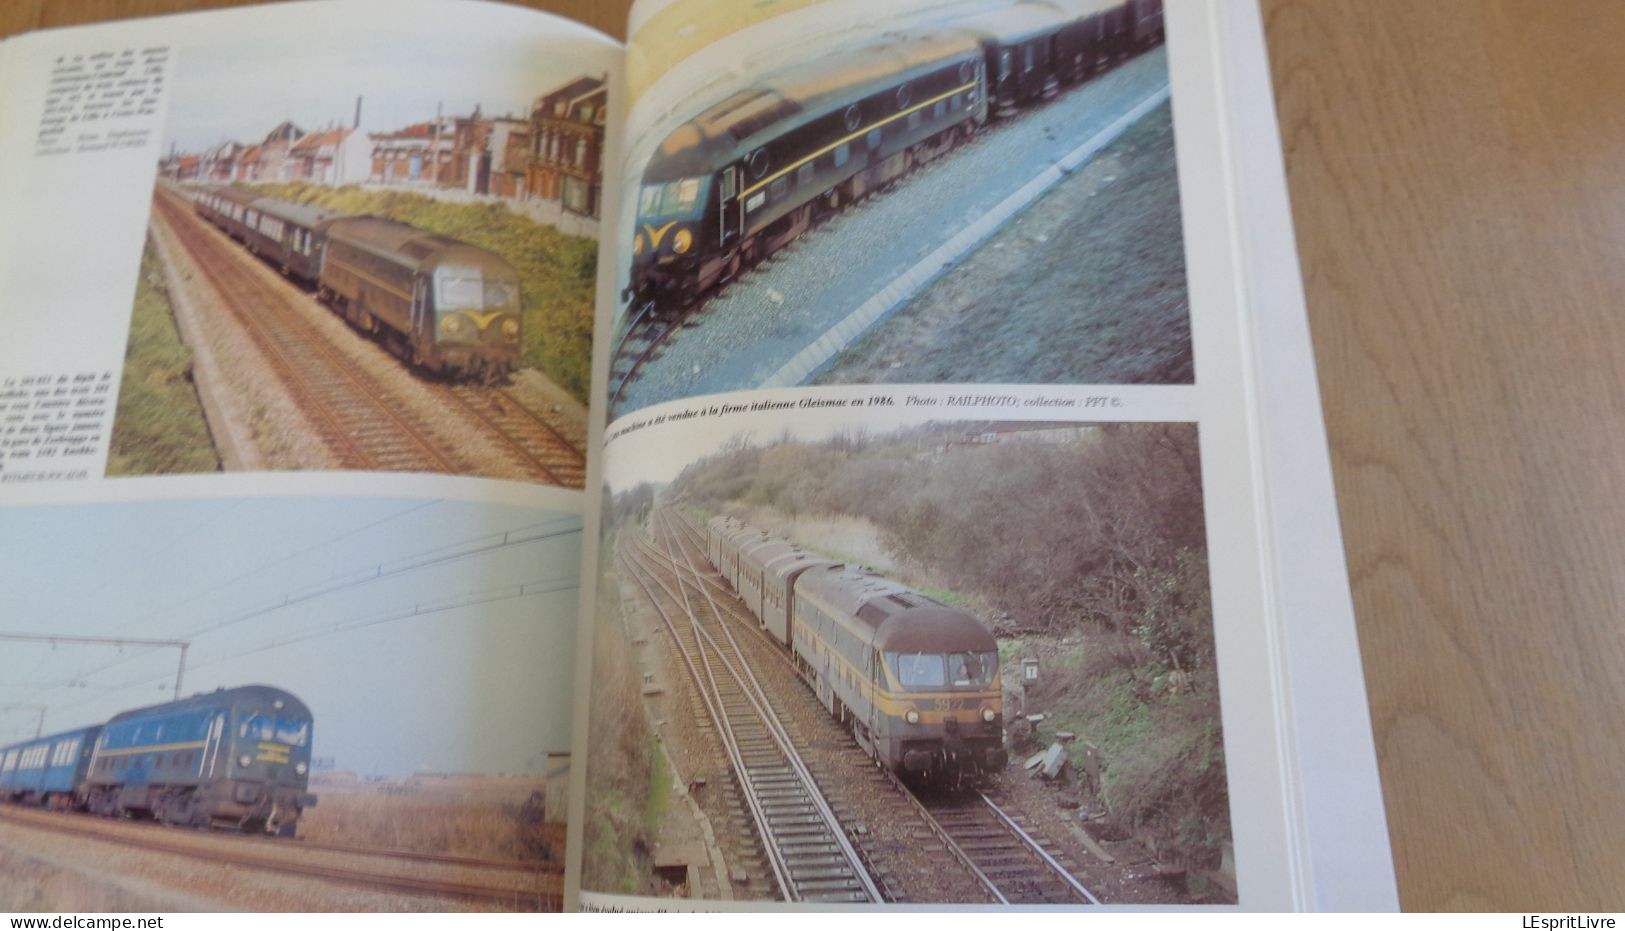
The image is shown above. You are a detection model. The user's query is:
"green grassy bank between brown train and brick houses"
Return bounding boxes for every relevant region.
[240,182,598,403]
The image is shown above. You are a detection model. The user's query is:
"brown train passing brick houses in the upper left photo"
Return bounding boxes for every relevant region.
[193,187,523,383]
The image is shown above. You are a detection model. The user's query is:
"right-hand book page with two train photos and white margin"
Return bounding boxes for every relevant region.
[572,0,1391,910]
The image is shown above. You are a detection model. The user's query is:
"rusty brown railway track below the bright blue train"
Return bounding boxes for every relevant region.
[0,808,564,912]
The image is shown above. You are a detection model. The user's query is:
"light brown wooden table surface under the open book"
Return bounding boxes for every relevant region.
[0,0,1625,912]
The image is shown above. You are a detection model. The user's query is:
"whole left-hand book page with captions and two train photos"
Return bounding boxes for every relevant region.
[0,2,622,913]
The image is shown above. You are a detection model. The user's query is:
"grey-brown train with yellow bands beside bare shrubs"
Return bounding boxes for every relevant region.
[705,517,1009,782]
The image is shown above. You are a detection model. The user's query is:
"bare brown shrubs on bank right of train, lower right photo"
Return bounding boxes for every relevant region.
[666,424,1230,868]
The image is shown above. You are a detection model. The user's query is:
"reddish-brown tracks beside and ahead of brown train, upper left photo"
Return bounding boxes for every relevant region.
[154,185,587,487]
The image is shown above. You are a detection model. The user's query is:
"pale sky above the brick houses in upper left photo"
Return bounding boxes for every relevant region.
[164,16,605,153]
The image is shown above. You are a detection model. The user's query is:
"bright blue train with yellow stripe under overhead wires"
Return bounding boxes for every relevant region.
[0,686,315,837]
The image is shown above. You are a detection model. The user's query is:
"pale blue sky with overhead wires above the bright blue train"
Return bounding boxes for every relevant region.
[0,497,582,775]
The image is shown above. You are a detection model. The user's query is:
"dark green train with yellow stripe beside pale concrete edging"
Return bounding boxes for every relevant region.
[622,0,1162,309]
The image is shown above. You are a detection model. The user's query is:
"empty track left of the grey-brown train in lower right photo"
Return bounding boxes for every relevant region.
[622,532,886,903]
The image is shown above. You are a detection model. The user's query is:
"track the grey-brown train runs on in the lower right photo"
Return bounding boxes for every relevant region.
[640,510,1100,905]
